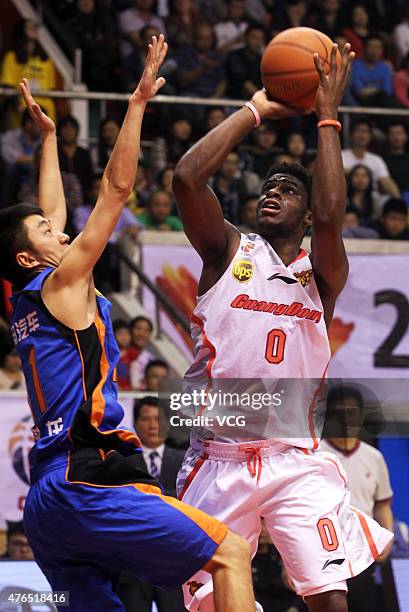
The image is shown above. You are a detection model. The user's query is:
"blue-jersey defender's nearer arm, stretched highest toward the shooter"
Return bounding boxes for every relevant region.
[53,35,167,285]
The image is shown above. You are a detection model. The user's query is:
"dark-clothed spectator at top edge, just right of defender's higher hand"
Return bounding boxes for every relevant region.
[166,0,200,49]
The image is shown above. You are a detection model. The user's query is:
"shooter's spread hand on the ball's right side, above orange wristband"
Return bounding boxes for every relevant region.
[314,43,355,120]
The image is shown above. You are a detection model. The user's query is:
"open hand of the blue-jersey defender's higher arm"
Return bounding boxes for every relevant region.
[129,34,168,103]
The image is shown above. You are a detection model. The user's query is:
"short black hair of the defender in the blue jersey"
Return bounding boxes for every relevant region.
[0,204,44,288]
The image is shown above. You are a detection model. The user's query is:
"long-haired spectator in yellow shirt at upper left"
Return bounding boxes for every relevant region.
[0,19,57,122]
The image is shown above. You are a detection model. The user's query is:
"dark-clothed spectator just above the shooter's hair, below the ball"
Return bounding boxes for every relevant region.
[240,121,278,178]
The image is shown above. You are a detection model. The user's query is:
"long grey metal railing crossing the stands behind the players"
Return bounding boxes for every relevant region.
[0,87,409,144]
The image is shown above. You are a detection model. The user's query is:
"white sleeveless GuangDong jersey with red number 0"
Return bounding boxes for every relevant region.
[184,234,330,448]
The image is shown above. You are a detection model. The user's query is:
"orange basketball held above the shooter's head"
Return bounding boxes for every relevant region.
[261,28,341,111]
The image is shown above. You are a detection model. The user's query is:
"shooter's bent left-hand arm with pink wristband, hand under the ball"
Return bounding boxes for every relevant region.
[173,91,294,263]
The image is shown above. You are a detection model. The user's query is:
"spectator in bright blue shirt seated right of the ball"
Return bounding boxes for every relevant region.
[351,35,396,108]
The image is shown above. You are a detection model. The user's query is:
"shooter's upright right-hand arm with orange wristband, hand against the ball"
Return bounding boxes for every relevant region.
[311,44,354,325]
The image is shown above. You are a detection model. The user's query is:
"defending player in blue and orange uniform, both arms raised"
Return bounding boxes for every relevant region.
[0,36,255,612]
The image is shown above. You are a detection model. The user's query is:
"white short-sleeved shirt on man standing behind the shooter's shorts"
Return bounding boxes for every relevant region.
[319,440,393,517]
